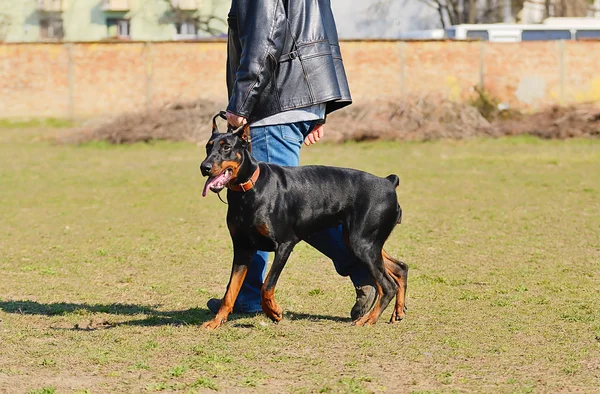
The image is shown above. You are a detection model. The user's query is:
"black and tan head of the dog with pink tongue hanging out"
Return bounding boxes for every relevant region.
[200,125,250,196]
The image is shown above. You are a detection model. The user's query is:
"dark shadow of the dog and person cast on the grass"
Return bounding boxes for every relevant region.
[0,300,351,330]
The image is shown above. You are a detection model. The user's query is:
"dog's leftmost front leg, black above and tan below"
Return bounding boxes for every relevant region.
[202,245,254,330]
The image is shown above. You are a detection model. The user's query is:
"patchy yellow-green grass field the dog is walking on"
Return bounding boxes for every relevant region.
[0,128,600,393]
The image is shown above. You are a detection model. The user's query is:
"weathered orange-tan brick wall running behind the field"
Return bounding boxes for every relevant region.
[0,41,600,117]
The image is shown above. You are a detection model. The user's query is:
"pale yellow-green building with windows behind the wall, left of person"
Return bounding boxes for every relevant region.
[0,0,229,42]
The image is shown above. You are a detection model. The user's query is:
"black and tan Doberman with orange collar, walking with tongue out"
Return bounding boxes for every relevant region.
[200,112,408,329]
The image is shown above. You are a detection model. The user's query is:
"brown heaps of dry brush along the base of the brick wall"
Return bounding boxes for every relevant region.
[58,97,600,144]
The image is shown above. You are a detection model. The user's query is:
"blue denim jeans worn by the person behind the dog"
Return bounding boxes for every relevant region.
[235,121,372,312]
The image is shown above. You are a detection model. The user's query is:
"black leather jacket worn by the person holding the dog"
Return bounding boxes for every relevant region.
[227,0,352,123]
